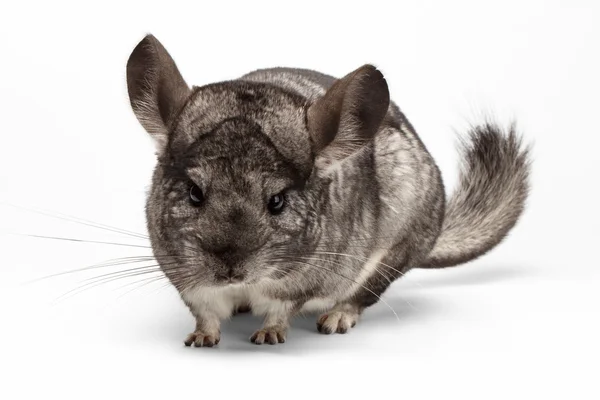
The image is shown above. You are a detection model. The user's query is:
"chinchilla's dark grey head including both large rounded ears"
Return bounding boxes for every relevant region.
[127,35,389,290]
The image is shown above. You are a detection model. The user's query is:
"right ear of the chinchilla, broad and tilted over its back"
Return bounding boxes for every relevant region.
[307,65,390,161]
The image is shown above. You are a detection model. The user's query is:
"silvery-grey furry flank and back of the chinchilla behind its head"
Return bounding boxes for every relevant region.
[241,68,445,311]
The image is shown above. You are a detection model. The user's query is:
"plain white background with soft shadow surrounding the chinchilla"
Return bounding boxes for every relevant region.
[0,0,600,399]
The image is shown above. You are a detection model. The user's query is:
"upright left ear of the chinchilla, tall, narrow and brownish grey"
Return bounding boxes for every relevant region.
[127,35,191,154]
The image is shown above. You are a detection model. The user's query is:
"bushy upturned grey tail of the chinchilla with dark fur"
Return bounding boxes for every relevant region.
[418,123,530,268]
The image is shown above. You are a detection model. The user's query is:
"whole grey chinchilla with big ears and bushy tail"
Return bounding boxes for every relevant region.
[127,35,530,347]
